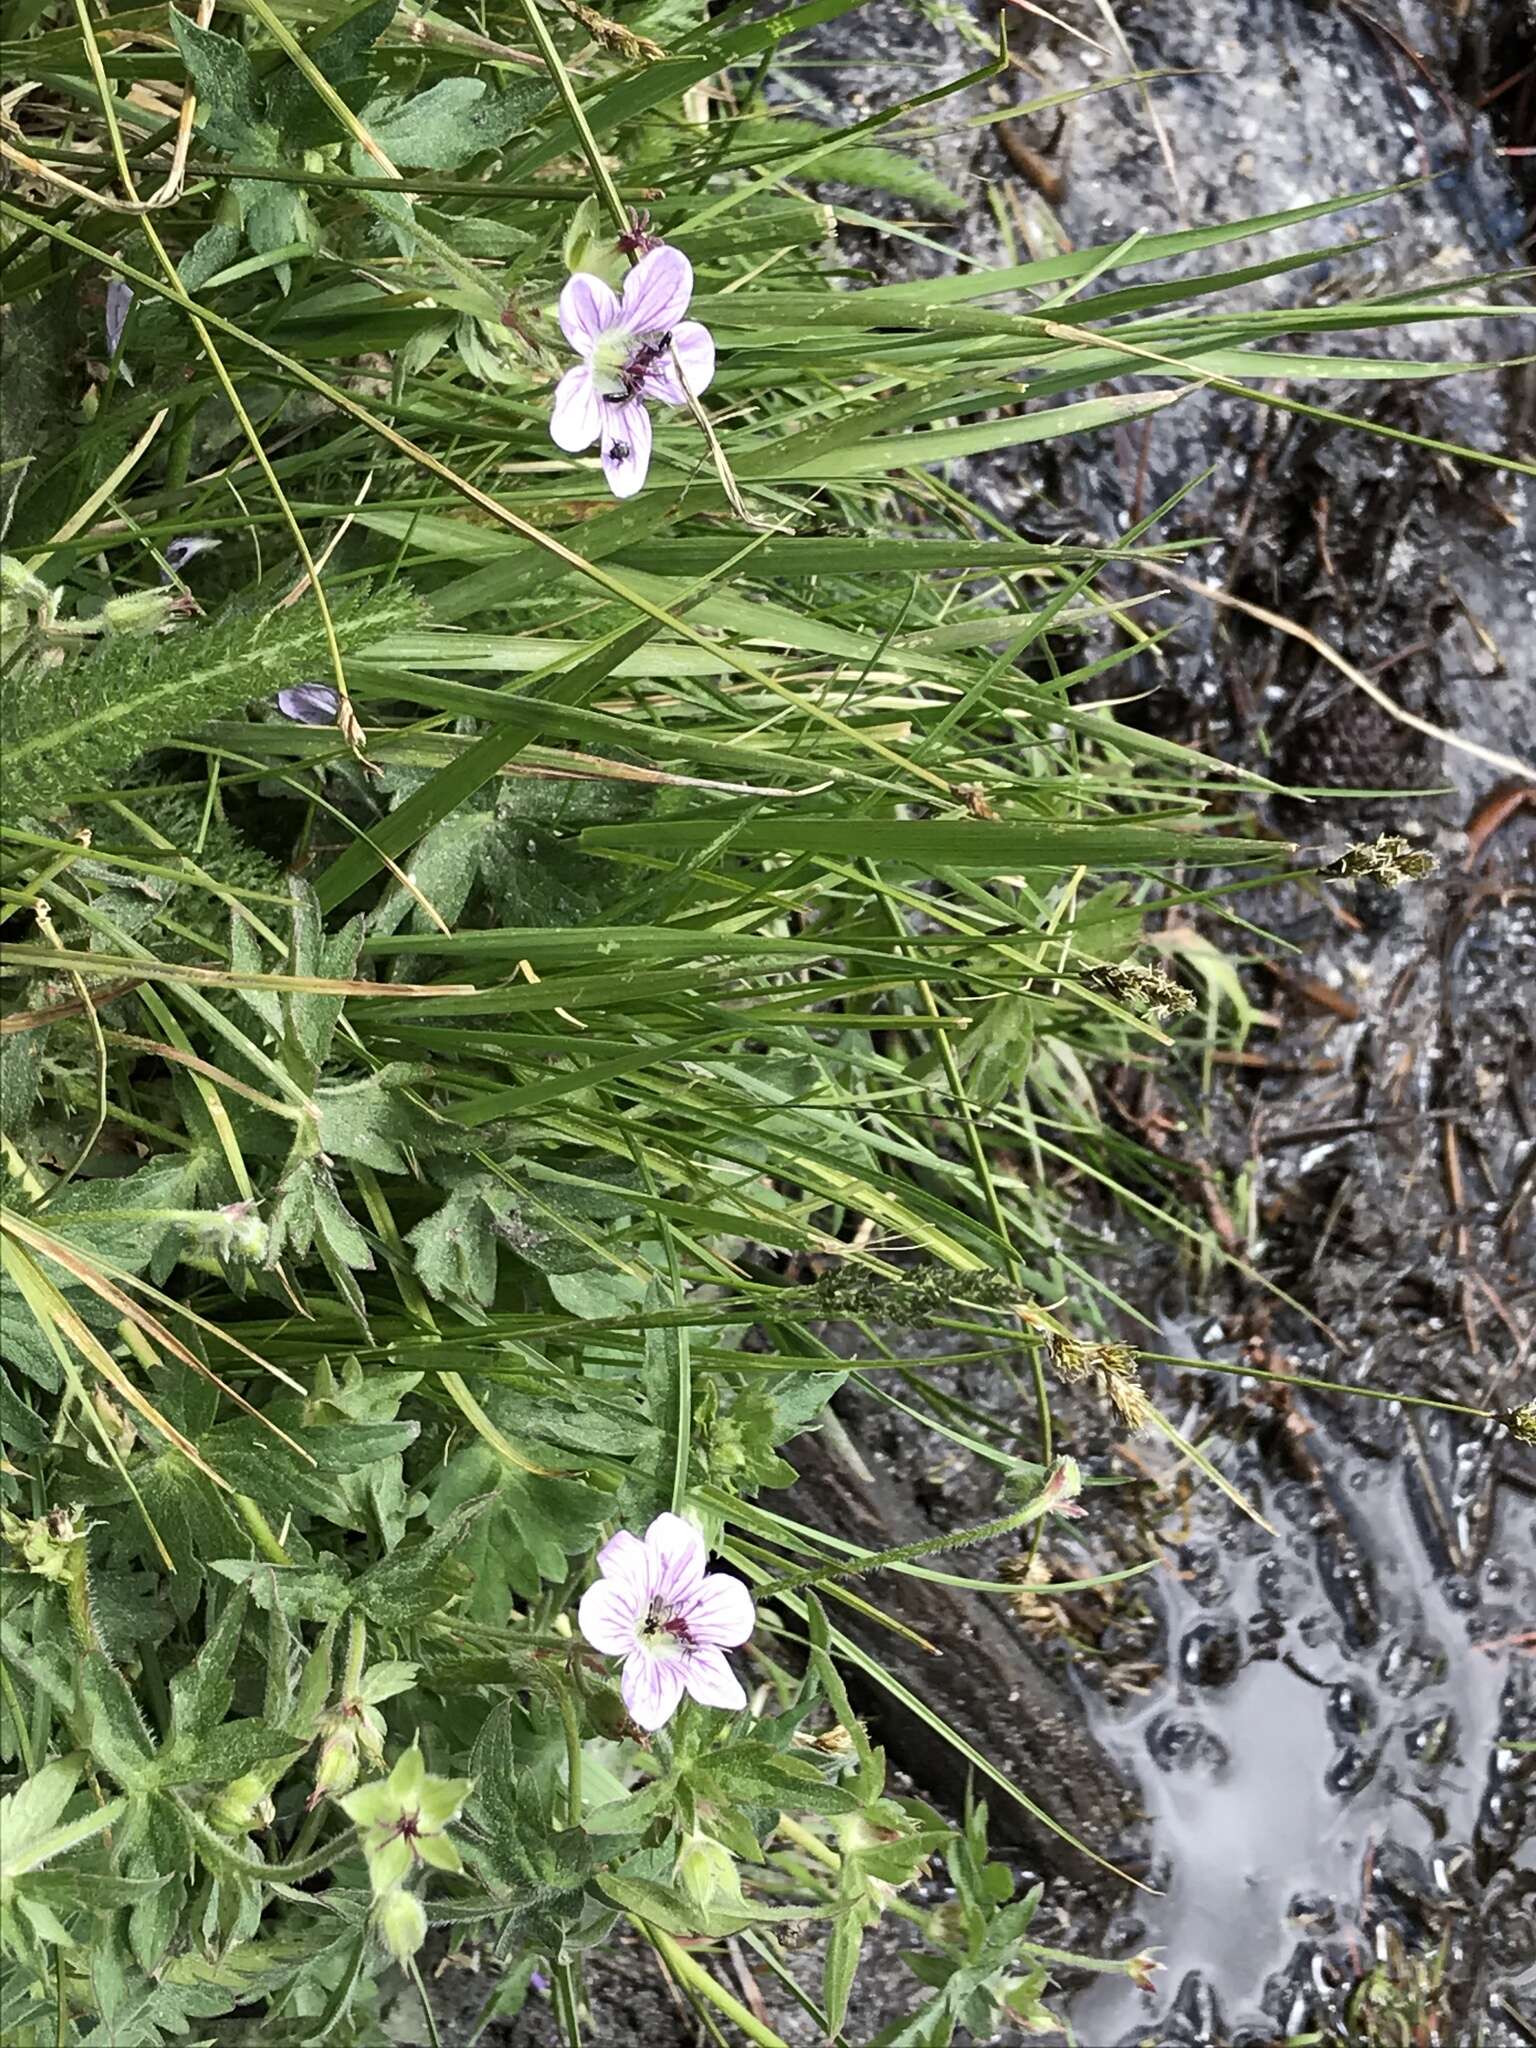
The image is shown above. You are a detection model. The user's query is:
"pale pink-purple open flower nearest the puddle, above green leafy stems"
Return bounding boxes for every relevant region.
[578,1516,758,1729]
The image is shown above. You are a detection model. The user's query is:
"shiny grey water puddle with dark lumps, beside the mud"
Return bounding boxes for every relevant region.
[1073,1425,1536,2048]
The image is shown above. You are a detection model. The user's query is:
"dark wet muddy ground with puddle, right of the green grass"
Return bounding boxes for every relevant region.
[436,0,1536,2048]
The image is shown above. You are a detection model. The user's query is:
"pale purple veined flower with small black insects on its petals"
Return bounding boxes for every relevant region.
[549,242,715,498]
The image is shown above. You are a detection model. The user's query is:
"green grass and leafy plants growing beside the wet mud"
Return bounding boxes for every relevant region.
[0,0,1531,2048]
